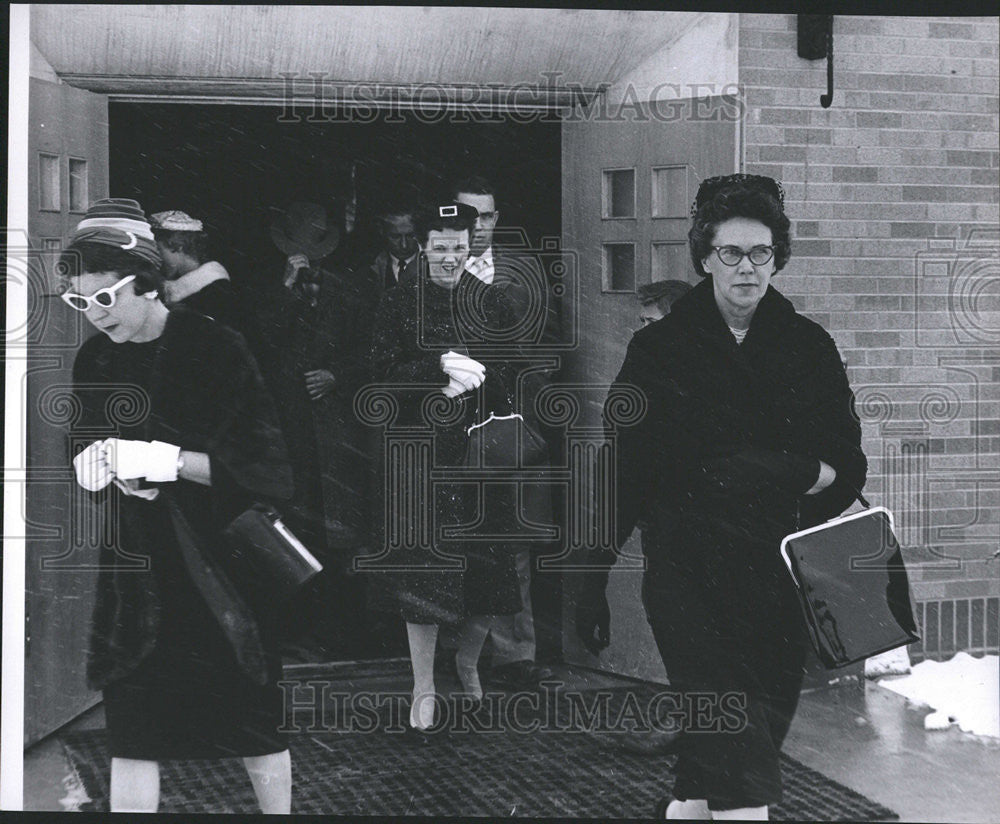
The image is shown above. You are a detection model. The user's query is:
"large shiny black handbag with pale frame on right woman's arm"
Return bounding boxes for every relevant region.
[781,495,920,669]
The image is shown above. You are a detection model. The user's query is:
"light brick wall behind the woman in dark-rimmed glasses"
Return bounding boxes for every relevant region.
[739,14,1000,648]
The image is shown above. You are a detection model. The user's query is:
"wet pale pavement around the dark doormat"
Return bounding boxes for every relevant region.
[24,662,1000,822]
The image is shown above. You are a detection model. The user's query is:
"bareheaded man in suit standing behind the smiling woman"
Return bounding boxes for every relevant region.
[451,176,554,690]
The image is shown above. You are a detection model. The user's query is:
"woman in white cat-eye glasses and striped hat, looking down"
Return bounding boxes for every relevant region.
[60,199,291,814]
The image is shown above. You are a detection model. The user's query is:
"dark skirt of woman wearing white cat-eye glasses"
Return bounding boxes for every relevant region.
[104,524,288,761]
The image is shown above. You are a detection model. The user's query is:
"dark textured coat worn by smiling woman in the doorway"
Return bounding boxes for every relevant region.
[371,268,520,623]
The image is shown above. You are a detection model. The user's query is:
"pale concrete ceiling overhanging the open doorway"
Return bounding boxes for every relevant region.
[31,4,703,94]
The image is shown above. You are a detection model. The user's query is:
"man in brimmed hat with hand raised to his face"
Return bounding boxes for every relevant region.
[256,202,378,654]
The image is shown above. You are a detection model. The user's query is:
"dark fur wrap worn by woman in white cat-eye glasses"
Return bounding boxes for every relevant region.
[73,309,292,689]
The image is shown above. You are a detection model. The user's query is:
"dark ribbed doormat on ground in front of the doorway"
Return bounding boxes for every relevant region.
[62,688,899,821]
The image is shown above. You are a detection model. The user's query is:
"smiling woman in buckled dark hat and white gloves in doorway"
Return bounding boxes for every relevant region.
[372,203,520,730]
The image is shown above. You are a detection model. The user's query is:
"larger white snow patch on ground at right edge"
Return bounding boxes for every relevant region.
[878,652,1000,738]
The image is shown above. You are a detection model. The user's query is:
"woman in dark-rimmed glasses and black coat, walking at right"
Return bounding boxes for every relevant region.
[577,174,867,820]
